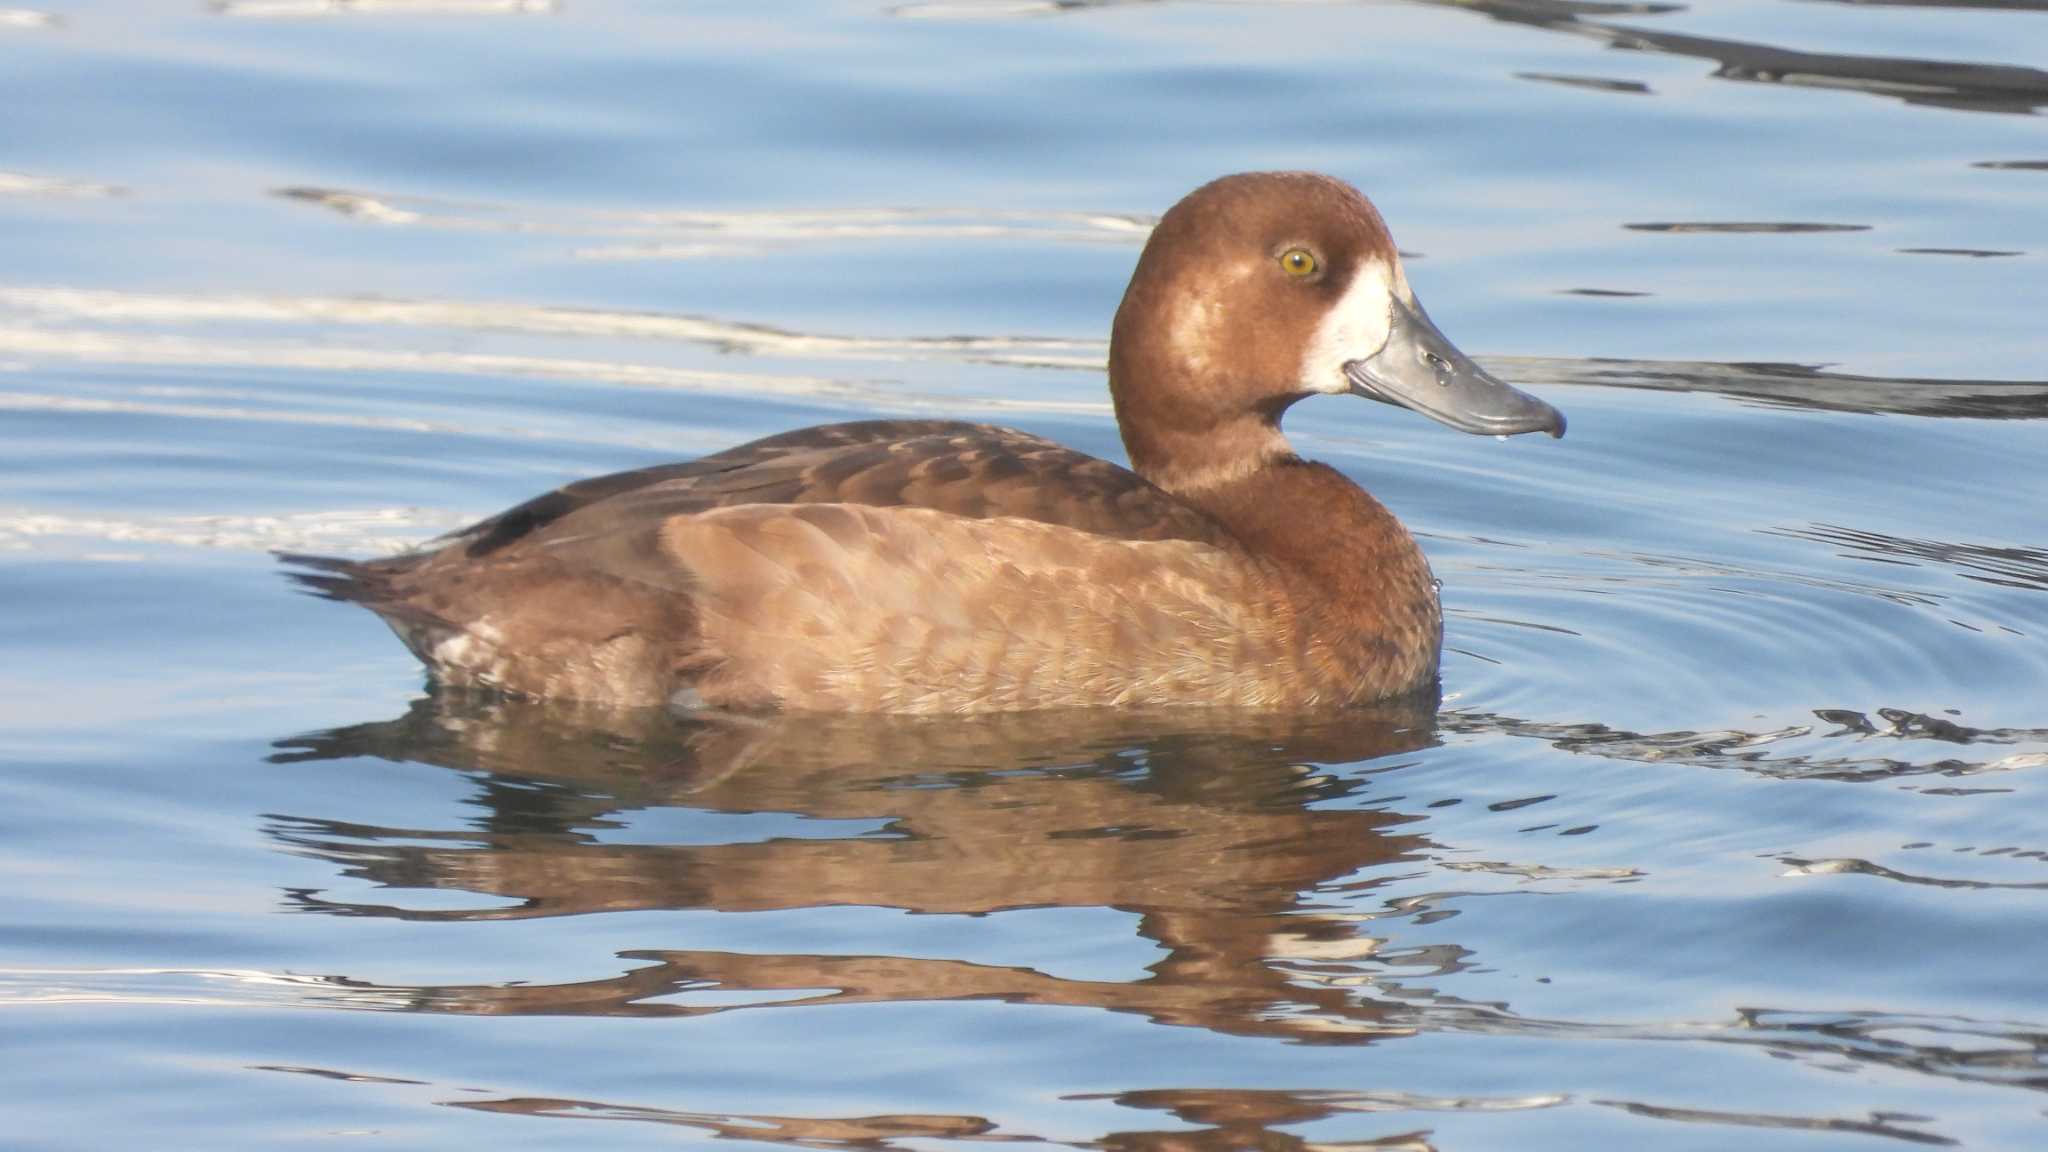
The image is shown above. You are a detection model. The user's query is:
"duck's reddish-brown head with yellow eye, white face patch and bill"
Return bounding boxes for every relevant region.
[1110,172,1565,488]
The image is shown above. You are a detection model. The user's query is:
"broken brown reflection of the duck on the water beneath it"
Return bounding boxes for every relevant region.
[270,693,1462,1039]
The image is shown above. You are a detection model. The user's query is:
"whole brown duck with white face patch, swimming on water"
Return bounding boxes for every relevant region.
[285,172,1565,713]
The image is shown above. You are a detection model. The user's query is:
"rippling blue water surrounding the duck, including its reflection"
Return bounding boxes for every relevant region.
[0,0,2048,1152]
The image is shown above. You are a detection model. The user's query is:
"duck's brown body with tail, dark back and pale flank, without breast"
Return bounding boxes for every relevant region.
[292,420,1307,711]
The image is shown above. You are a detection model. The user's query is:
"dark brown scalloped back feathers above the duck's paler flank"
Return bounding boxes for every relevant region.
[440,420,1221,560]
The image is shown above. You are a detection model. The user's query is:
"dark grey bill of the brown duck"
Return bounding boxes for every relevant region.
[1343,299,1565,437]
